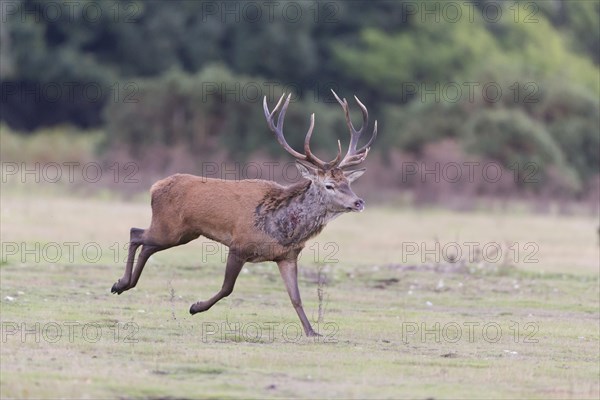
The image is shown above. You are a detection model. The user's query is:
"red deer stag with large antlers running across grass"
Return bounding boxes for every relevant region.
[112,91,377,336]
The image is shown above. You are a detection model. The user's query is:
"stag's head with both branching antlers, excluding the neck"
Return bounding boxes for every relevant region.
[263,90,377,213]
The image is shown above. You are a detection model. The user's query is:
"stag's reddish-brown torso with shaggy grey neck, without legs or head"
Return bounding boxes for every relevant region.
[142,174,340,262]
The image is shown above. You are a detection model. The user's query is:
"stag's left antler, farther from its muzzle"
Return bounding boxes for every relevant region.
[263,93,342,169]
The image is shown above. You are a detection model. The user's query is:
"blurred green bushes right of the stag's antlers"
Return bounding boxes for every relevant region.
[380,76,600,191]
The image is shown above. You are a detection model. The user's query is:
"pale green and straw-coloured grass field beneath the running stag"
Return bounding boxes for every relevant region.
[0,192,600,399]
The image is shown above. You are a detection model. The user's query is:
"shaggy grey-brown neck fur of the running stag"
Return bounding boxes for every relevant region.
[255,180,336,246]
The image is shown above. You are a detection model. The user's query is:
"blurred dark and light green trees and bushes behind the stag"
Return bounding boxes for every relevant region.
[0,0,600,197]
